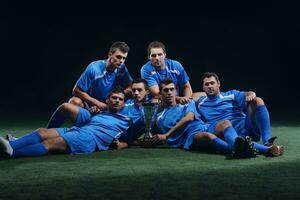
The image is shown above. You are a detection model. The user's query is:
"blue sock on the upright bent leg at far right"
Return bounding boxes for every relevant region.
[254,105,271,144]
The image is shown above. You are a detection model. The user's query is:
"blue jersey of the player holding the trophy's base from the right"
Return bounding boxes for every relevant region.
[155,101,207,149]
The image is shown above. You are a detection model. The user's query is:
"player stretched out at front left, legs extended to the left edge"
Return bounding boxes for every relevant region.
[0,88,131,157]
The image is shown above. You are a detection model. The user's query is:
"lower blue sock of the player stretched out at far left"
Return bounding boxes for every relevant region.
[12,143,48,157]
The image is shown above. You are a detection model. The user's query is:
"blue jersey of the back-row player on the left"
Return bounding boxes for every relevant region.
[76,60,132,102]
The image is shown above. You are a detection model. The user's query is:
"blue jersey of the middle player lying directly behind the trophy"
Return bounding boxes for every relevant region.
[120,99,146,144]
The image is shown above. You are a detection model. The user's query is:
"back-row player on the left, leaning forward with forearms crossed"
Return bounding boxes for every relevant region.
[47,41,132,128]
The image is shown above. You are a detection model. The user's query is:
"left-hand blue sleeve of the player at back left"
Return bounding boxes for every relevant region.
[76,63,95,92]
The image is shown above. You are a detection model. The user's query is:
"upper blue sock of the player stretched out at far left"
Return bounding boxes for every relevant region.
[9,131,42,150]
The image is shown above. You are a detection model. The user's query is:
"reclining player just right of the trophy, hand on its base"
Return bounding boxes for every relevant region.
[152,79,248,153]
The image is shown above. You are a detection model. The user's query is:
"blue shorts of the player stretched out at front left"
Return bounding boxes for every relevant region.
[56,127,97,154]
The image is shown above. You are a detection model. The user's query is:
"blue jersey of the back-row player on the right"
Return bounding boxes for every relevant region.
[141,59,190,95]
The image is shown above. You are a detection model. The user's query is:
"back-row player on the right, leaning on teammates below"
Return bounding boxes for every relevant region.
[141,41,192,104]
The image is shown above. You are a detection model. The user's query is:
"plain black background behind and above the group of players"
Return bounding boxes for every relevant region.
[0,1,300,119]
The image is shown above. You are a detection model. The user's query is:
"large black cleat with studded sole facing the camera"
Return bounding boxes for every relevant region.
[232,136,257,158]
